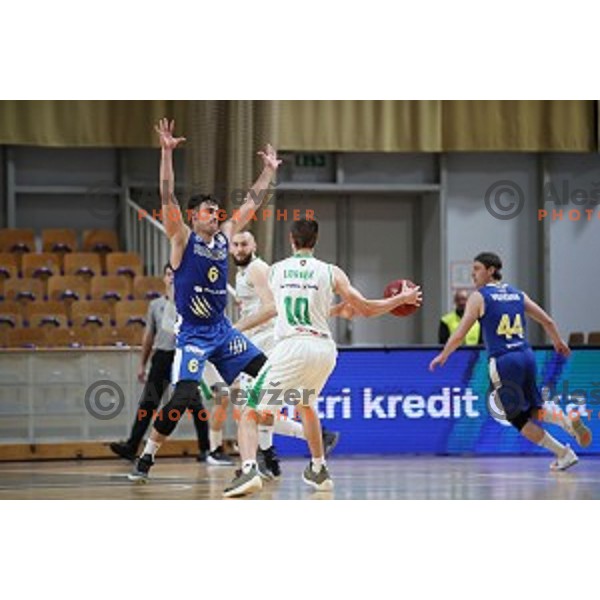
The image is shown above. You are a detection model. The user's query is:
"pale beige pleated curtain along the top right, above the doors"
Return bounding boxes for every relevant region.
[279,100,597,152]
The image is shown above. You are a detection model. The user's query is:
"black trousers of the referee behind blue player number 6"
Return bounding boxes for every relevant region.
[127,350,210,452]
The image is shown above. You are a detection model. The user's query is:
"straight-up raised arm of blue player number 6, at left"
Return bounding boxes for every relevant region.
[154,119,190,269]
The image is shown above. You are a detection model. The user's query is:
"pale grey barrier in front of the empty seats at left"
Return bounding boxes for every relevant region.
[0,348,236,450]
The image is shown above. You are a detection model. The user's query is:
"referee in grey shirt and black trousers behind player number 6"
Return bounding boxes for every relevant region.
[110,265,209,462]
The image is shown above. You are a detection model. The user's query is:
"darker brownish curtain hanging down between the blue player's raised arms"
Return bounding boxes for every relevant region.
[185,100,278,261]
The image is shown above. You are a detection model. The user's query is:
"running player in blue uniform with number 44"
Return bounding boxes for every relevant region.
[429,252,592,471]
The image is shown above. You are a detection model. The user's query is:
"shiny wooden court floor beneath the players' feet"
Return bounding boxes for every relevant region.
[0,457,600,500]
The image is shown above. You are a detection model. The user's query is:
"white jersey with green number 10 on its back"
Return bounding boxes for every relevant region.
[269,254,333,340]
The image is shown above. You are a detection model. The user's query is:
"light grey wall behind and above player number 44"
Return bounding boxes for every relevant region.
[446,153,600,341]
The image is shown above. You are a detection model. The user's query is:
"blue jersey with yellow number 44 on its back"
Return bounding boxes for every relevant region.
[478,283,529,357]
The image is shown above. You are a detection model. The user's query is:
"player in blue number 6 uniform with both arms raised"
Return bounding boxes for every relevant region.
[129,119,281,482]
